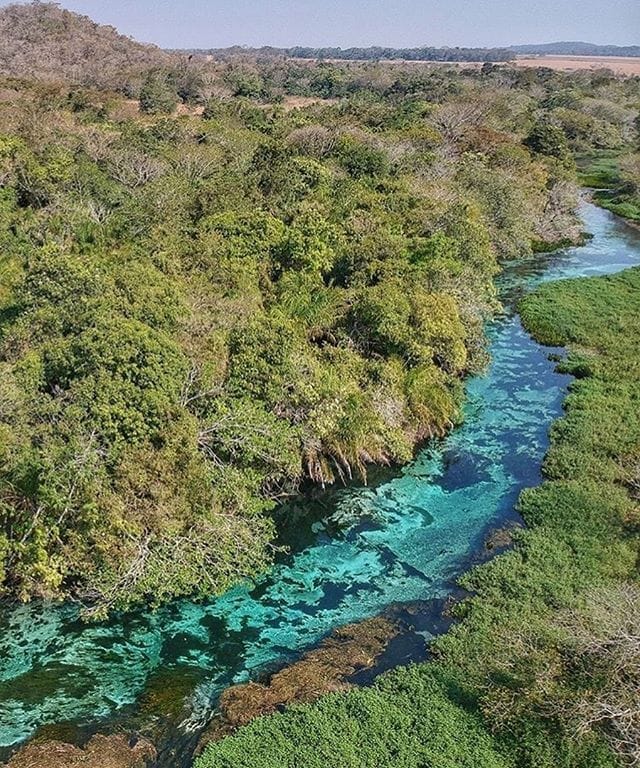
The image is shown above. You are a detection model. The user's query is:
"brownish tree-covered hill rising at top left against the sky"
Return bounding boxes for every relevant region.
[0,2,172,87]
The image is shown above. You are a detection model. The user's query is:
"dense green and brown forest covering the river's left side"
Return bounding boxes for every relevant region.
[0,0,638,611]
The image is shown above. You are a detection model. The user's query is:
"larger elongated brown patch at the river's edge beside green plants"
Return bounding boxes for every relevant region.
[198,618,398,752]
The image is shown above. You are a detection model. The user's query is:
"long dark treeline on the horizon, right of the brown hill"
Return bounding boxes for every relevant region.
[188,46,516,62]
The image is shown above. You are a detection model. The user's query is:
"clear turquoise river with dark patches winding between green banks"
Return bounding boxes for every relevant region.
[0,204,640,756]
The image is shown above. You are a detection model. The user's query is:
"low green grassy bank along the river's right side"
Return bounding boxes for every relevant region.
[196,269,640,768]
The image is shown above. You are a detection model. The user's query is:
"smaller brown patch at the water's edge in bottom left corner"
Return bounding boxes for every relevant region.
[7,734,156,768]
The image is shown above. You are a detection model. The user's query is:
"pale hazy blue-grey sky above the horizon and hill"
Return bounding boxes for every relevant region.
[6,0,640,48]
